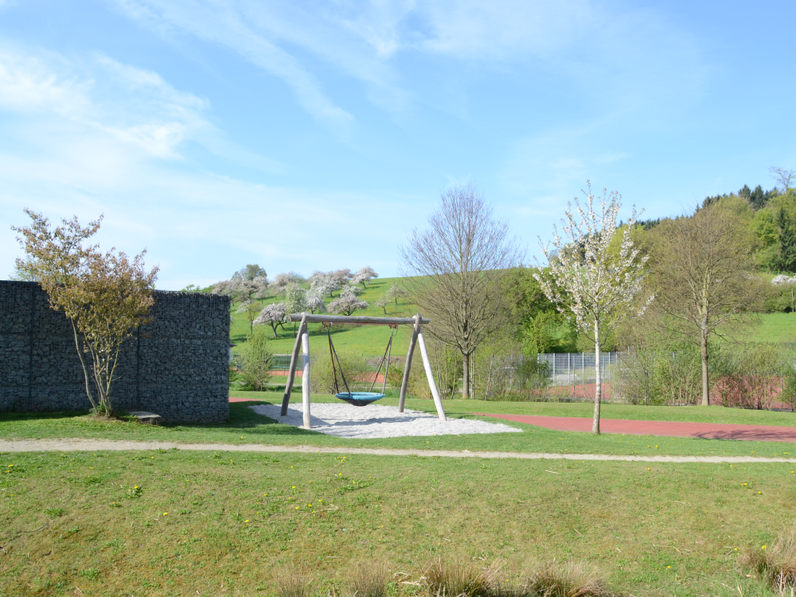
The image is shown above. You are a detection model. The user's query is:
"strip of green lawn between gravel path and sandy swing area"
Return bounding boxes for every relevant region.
[0,392,796,457]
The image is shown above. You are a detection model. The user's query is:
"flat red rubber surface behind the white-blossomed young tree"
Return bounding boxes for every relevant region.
[473,413,796,443]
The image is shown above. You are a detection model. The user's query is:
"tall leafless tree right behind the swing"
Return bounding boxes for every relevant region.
[401,183,521,398]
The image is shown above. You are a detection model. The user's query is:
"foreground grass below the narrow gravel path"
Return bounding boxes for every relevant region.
[0,450,796,597]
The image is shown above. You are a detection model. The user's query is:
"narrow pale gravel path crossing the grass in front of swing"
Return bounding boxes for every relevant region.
[0,438,796,464]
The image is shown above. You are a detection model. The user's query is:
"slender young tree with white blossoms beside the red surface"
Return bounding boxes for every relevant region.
[534,185,652,433]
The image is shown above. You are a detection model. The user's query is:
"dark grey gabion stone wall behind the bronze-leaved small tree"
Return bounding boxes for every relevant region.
[0,280,230,423]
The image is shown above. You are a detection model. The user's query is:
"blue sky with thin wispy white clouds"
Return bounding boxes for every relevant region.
[0,0,796,290]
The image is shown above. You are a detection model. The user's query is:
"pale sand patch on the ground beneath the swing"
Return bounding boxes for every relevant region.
[250,402,520,438]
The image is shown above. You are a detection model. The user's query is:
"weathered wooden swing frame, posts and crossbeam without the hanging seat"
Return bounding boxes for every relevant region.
[281,312,447,429]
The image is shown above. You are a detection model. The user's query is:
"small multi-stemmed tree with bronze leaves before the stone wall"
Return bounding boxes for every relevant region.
[13,209,158,416]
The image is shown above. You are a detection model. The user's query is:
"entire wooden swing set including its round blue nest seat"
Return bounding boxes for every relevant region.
[281,313,446,429]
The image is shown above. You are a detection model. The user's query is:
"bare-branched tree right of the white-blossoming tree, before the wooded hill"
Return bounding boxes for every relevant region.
[652,201,763,406]
